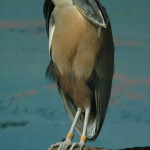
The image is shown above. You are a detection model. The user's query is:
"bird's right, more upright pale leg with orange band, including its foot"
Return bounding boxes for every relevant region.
[70,107,91,150]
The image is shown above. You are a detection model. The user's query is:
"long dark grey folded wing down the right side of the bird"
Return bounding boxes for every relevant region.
[87,22,114,140]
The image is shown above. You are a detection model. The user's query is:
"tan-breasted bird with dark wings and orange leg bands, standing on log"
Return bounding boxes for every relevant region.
[43,0,114,150]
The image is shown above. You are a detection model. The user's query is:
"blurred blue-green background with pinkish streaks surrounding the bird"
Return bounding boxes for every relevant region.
[0,0,150,150]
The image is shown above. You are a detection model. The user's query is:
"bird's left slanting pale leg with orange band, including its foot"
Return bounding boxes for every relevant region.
[49,108,81,150]
